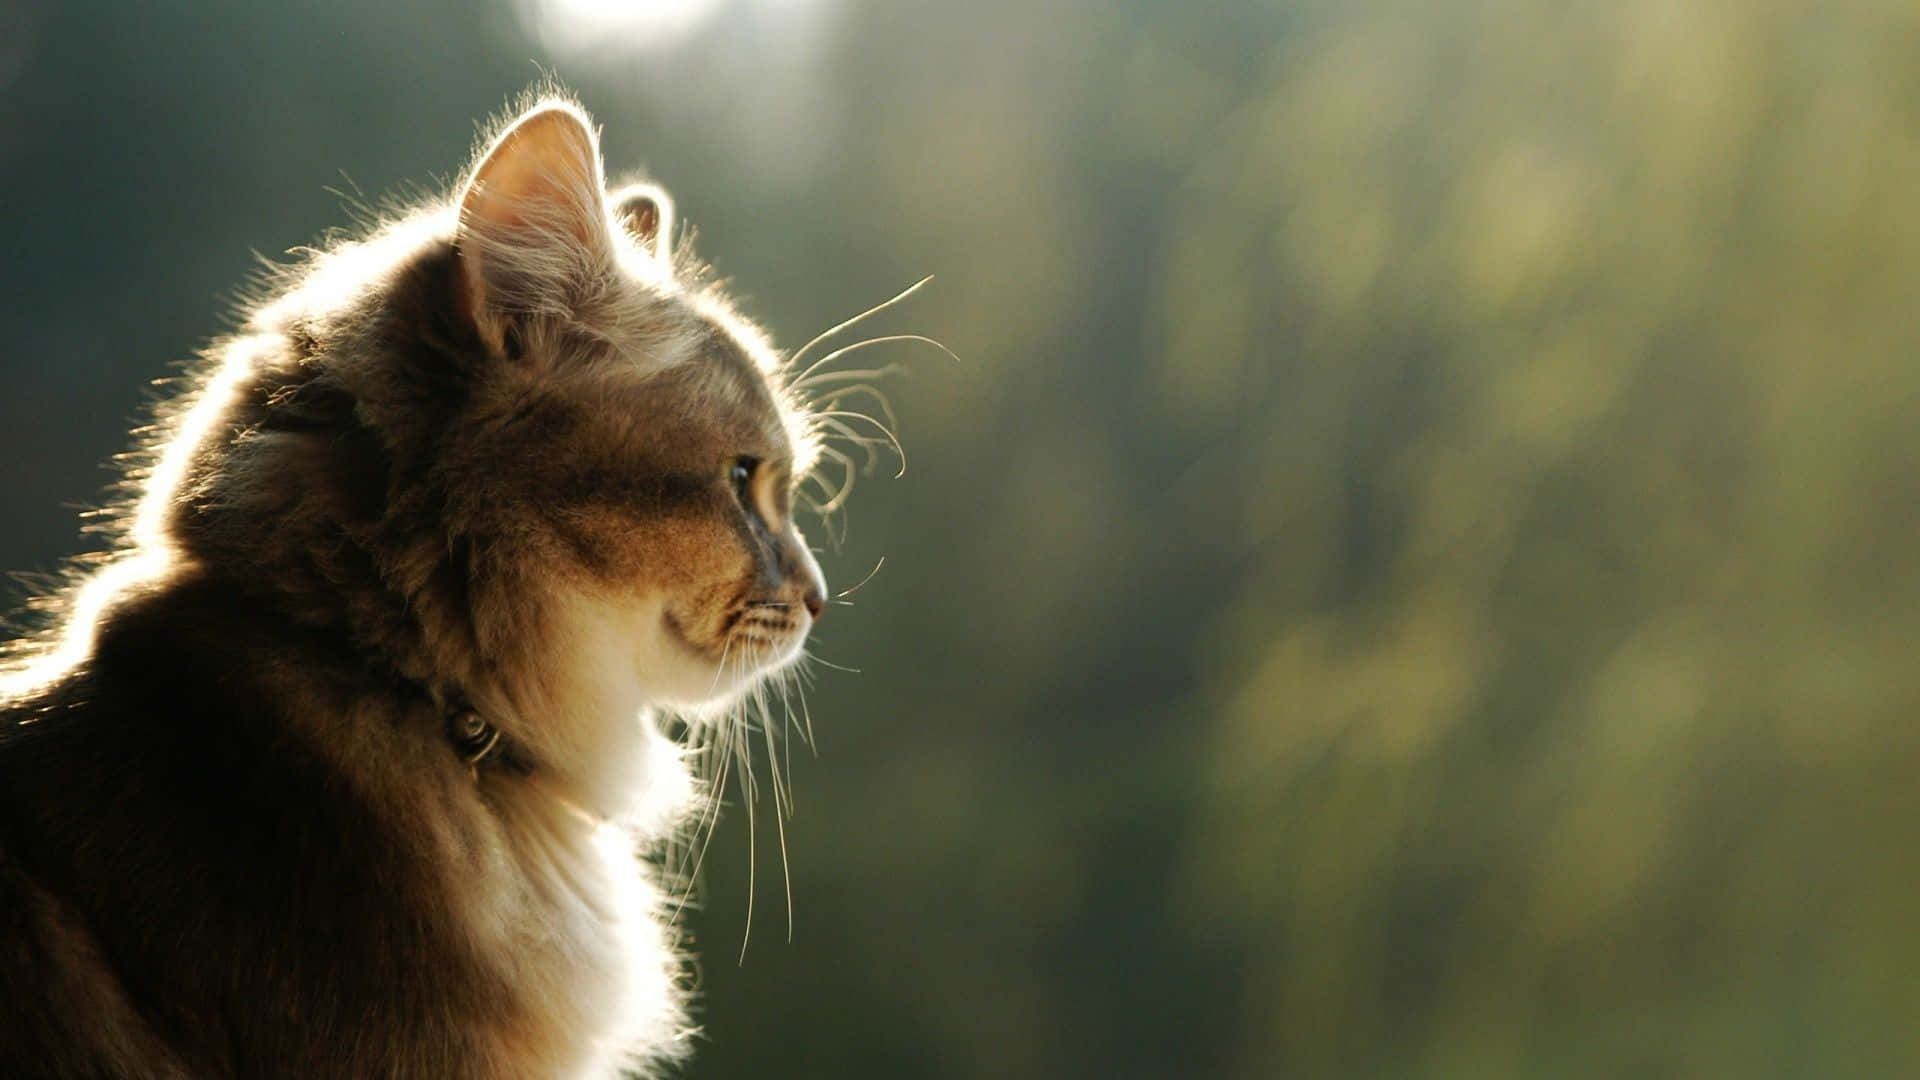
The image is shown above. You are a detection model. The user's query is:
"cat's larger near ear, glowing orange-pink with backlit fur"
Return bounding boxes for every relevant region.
[453,102,612,346]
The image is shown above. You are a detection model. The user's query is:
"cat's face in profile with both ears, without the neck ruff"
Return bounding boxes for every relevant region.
[451,102,826,703]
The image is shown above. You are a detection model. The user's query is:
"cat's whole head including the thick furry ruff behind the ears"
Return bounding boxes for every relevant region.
[178,100,826,757]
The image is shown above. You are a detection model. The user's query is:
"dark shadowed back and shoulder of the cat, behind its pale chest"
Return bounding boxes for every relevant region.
[0,580,526,1076]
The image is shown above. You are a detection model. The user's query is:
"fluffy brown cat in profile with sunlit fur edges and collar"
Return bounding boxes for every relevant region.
[0,94,831,1078]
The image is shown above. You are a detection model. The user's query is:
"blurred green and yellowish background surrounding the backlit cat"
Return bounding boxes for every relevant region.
[0,0,1920,1078]
